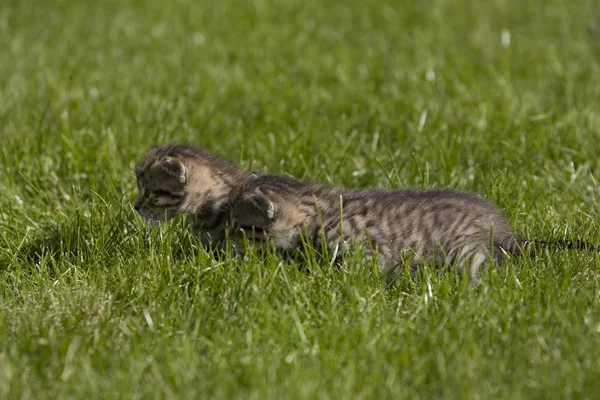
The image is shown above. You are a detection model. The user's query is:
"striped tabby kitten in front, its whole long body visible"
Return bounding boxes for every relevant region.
[230,175,524,280]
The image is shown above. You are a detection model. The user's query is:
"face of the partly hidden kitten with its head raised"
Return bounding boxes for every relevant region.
[134,157,188,222]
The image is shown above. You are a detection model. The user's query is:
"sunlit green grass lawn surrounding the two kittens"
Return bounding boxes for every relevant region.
[0,0,600,399]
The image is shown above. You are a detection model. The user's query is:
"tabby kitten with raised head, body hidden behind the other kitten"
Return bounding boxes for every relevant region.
[134,144,247,246]
